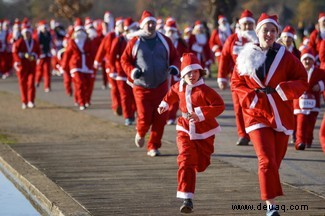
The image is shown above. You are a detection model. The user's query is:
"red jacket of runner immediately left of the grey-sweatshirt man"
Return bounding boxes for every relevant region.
[108,35,127,81]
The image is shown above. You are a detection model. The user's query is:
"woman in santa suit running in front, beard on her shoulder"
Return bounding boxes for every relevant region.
[232,13,308,216]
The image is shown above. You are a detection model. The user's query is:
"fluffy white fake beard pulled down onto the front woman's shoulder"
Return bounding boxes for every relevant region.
[236,43,267,77]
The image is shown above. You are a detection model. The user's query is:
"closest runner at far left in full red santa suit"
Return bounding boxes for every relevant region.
[13,23,40,109]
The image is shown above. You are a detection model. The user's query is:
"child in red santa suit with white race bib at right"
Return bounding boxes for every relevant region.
[293,48,325,150]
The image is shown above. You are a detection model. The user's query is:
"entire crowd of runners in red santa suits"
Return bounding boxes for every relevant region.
[0,10,325,216]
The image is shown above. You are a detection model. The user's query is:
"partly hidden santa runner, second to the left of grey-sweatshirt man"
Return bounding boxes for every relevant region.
[94,17,123,115]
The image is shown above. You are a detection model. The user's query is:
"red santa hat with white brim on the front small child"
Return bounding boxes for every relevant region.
[181,53,205,78]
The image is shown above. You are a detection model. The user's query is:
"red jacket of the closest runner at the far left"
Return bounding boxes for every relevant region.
[12,37,40,70]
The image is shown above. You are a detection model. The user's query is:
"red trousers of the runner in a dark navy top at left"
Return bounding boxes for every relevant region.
[36,57,51,89]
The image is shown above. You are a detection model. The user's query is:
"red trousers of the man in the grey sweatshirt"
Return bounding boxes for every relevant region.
[133,81,168,151]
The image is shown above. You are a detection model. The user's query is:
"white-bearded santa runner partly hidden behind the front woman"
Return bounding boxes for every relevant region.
[218,10,257,145]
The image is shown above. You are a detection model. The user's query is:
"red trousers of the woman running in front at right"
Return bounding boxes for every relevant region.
[249,127,289,200]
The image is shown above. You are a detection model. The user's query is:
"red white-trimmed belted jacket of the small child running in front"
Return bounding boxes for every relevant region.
[159,78,225,140]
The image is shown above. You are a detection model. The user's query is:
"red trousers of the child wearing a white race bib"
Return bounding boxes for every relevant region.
[295,112,318,145]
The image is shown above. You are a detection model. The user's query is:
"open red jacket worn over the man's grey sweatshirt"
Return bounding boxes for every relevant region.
[121,32,180,82]
